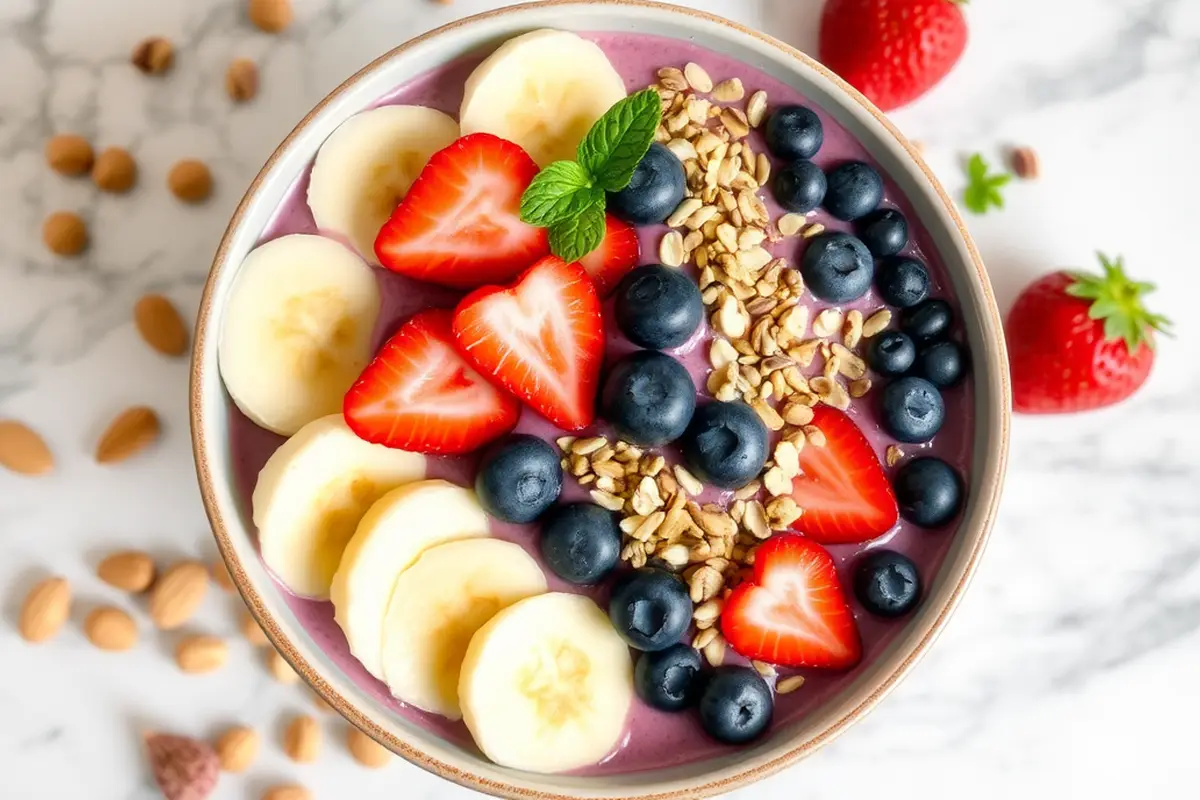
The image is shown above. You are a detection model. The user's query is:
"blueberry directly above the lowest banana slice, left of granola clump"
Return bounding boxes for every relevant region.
[538,503,620,585]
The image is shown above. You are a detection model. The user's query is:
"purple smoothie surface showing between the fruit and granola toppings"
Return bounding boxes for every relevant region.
[229,34,973,775]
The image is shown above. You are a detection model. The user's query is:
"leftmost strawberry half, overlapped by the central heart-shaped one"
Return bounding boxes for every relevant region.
[342,308,521,453]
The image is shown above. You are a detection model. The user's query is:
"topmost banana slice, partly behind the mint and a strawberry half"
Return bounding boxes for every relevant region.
[458,29,625,167]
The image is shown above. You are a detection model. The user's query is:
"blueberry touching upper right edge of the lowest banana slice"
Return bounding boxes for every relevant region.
[608,567,691,651]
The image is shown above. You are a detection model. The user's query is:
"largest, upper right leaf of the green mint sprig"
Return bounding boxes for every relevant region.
[577,89,662,192]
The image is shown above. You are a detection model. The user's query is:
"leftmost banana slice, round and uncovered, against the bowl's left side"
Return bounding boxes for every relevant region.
[217,234,379,435]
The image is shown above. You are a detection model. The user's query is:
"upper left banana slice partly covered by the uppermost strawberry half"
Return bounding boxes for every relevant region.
[308,106,458,264]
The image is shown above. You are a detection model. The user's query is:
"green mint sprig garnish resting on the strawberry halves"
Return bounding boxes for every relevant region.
[521,89,662,261]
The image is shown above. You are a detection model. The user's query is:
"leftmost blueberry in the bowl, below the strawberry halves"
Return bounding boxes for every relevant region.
[475,433,563,523]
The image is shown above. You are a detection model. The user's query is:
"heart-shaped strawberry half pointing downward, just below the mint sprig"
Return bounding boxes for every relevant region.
[454,255,604,431]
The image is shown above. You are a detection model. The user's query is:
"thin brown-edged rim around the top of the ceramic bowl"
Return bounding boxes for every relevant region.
[188,0,1012,800]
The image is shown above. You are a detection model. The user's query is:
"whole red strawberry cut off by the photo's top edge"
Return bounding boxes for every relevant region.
[821,0,967,112]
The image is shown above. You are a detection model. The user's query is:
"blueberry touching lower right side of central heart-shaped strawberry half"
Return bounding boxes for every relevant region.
[600,350,696,447]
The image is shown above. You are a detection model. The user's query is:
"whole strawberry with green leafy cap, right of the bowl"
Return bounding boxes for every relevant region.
[1004,255,1170,414]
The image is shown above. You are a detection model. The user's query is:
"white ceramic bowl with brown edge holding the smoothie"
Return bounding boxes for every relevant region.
[191,1,1009,798]
